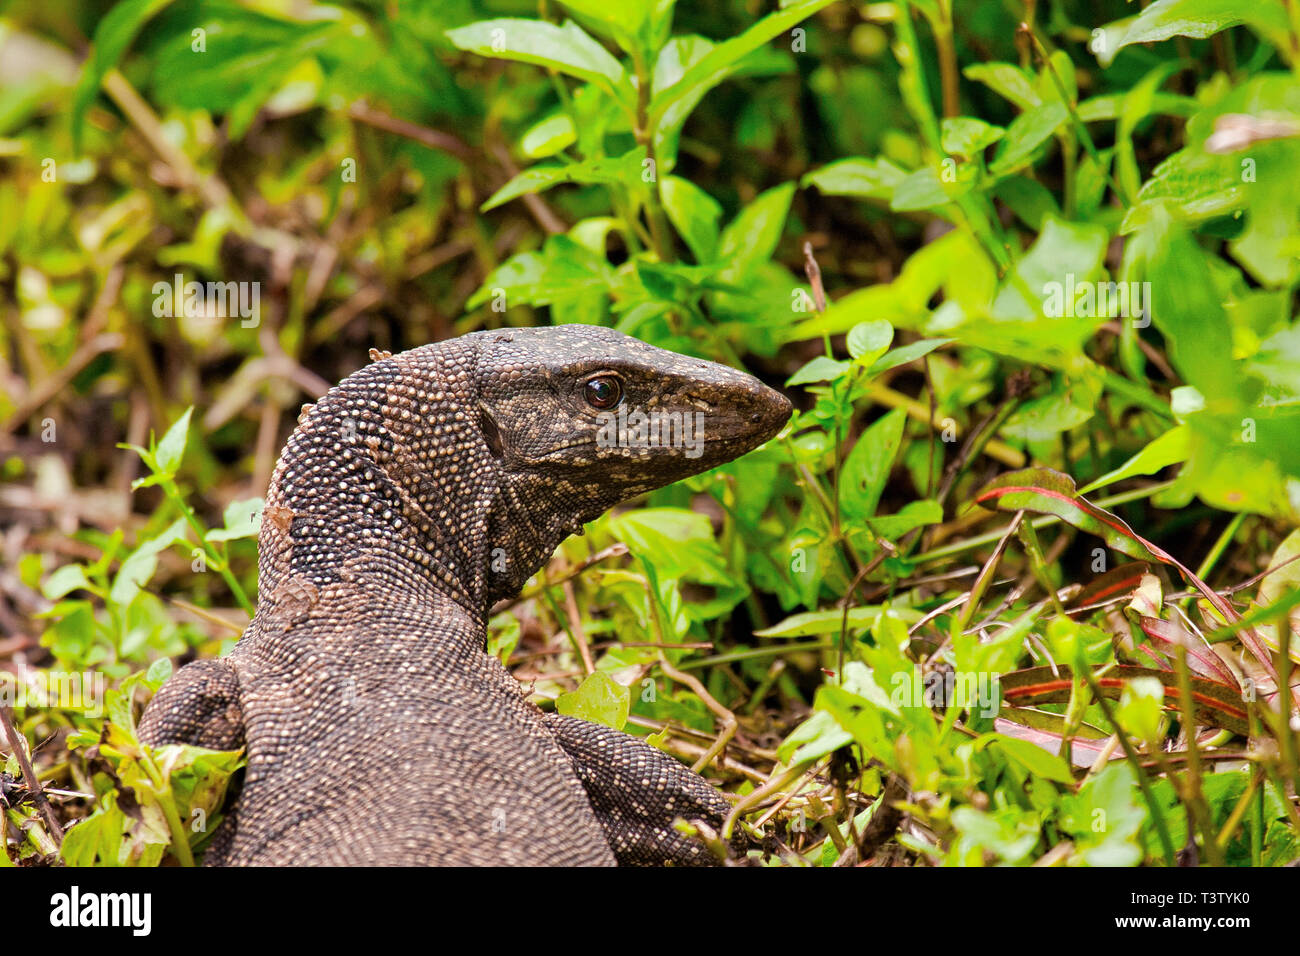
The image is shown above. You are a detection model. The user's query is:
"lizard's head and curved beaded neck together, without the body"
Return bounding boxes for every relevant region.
[259,325,790,611]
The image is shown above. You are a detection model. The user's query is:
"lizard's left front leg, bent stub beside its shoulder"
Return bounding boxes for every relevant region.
[139,659,244,750]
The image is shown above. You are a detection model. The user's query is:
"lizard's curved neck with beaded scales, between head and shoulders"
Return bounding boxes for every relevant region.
[259,336,581,622]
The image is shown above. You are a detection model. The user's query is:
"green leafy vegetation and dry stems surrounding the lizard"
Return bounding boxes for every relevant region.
[0,0,1300,866]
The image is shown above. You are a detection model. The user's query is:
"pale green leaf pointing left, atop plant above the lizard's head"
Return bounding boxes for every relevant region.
[447,17,633,108]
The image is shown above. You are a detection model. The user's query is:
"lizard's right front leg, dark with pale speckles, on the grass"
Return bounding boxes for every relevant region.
[545,714,731,866]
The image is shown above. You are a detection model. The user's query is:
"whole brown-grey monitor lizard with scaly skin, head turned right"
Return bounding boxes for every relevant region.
[140,325,790,865]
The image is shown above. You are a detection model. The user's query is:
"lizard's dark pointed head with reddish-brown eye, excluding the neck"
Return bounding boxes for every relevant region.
[476,325,790,593]
